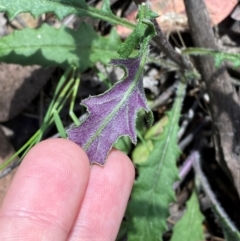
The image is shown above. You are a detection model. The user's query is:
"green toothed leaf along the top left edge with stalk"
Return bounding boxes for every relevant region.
[0,0,134,28]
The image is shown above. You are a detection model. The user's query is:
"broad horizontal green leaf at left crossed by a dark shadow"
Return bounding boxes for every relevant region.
[0,23,121,71]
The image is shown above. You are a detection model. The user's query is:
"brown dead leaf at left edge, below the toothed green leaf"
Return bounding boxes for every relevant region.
[0,63,54,122]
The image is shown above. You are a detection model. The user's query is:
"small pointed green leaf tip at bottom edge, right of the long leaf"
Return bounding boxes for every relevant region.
[171,191,204,241]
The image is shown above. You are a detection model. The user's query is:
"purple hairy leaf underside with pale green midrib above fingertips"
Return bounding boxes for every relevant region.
[68,58,149,165]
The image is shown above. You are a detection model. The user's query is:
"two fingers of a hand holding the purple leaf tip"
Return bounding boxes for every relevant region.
[0,139,134,241]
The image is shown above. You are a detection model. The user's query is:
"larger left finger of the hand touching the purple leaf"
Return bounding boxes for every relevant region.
[0,139,90,241]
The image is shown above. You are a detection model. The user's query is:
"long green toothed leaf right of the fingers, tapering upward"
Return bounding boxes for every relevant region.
[127,83,186,241]
